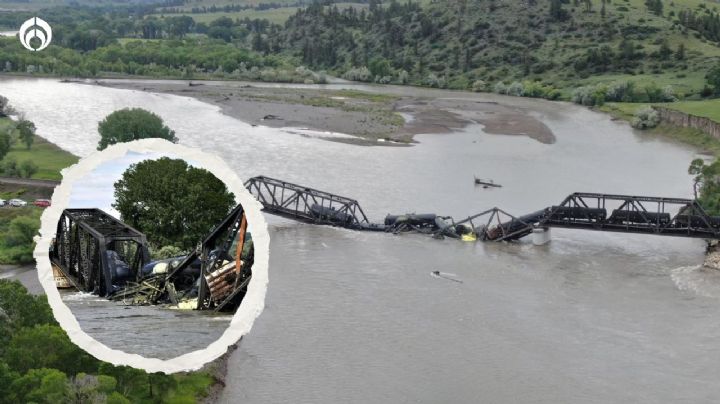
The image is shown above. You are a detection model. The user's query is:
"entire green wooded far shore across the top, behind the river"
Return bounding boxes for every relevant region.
[0,0,720,97]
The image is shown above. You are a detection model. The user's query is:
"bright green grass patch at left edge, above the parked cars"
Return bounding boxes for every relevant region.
[0,118,78,180]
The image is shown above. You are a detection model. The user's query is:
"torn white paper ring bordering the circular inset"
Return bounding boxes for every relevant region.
[34,139,270,373]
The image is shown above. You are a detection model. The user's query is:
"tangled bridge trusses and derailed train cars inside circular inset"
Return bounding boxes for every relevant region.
[50,205,254,311]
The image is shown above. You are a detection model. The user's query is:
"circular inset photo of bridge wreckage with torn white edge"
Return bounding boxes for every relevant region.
[35,139,269,372]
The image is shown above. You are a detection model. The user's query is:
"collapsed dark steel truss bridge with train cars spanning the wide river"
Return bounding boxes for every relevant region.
[245,176,720,241]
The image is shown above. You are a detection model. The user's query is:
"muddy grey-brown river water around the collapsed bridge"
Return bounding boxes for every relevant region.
[0,79,720,403]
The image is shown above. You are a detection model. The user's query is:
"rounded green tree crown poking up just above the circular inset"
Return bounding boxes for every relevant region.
[98,108,178,150]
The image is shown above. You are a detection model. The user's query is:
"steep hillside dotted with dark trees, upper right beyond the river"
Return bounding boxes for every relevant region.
[264,0,720,93]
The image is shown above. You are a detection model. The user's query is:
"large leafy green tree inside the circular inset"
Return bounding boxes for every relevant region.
[113,157,235,250]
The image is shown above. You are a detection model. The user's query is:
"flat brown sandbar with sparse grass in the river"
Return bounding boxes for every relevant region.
[94,80,555,145]
